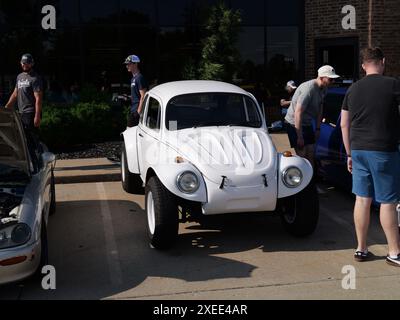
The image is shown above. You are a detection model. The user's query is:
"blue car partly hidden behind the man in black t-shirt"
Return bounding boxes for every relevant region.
[315,87,400,218]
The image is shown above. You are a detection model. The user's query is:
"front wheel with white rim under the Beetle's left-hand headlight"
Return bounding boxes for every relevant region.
[145,177,179,250]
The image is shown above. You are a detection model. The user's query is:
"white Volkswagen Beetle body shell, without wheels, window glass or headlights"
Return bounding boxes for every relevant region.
[122,81,313,248]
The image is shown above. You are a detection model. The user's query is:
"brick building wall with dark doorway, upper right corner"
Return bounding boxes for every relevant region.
[304,0,400,79]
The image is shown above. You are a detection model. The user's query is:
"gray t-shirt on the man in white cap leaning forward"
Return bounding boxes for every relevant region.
[285,80,327,126]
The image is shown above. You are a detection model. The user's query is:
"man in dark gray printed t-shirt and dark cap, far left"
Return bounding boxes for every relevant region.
[6,53,43,131]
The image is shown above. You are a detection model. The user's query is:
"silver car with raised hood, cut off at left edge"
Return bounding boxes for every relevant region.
[0,108,56,284]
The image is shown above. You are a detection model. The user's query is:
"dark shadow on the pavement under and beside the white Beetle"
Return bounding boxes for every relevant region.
[0,185,386,299]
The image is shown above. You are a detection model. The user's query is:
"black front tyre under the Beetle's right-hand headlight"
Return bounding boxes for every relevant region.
[280,183,319,237]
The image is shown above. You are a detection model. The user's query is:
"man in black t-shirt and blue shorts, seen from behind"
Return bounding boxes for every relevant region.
[341,48,400,267]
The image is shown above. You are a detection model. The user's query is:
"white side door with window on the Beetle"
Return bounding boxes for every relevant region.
[138,95,162,181]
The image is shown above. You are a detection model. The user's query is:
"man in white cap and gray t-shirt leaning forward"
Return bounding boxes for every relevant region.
[285,65,340,166]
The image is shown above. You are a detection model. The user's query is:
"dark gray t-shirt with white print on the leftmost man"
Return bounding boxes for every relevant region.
[15,71,43,113]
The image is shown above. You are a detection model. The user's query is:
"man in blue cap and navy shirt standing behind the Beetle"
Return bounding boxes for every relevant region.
[124,55,147,128]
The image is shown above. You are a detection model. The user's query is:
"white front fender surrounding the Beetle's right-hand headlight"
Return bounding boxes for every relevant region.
[278,154,314,199]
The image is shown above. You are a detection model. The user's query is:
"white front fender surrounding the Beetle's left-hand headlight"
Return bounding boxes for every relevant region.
[149,162,207,203]
